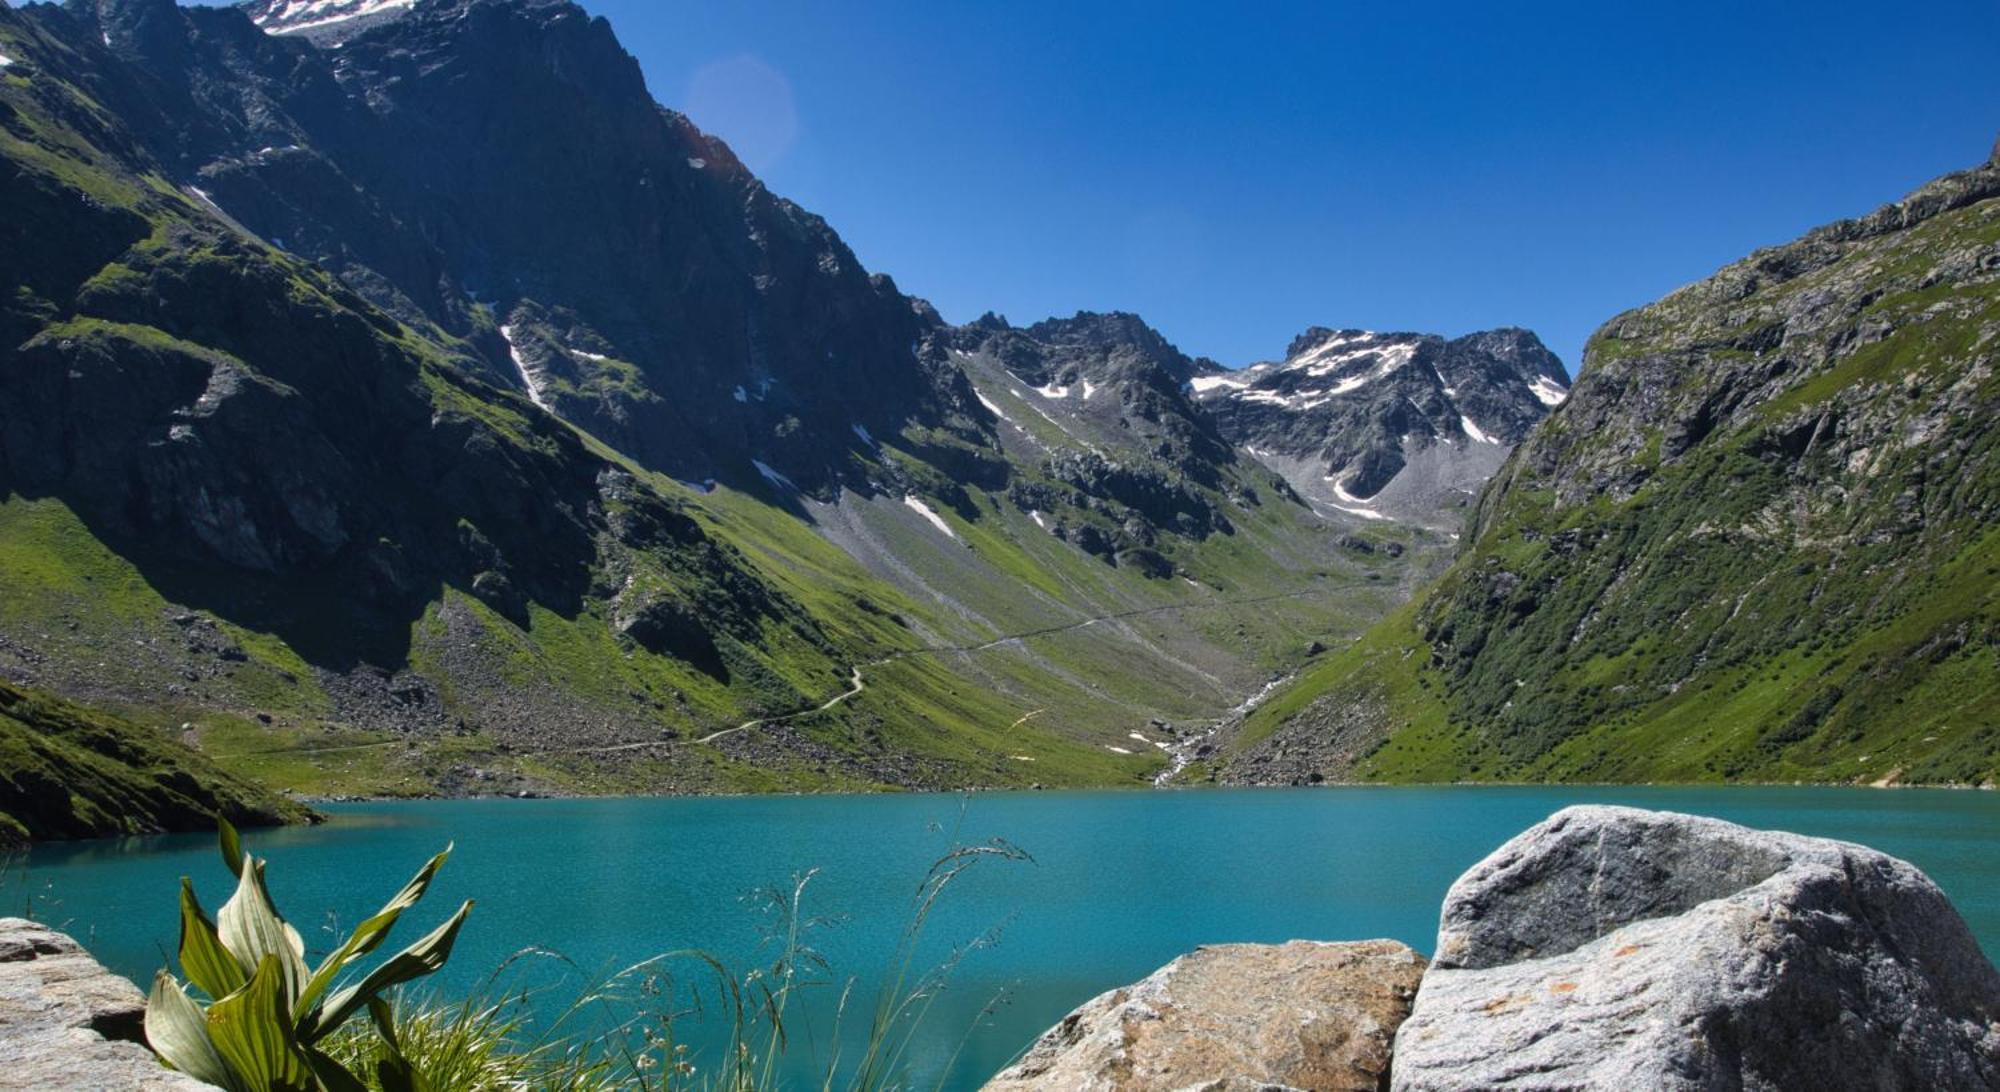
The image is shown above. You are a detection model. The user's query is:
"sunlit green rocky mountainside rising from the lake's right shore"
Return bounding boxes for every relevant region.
[1216,148,2000,784]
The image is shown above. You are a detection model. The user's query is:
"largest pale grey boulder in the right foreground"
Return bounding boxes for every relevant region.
[1392,806,2000,1092]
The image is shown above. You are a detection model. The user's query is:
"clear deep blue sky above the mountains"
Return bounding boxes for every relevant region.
[234,0,2000,372]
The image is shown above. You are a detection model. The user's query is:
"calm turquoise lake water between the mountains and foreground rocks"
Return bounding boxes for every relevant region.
[19,788,2000,1088]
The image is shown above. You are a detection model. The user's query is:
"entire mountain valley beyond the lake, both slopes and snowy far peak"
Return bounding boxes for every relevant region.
[0,0,2000,836]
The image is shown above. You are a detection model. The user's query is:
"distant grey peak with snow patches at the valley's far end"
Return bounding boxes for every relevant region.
[1192,326,1570,532]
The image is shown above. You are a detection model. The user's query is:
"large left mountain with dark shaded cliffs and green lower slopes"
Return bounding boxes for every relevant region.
[0,0,1438,794]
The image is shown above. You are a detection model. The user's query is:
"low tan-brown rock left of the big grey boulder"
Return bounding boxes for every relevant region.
[986,940,1424,1092]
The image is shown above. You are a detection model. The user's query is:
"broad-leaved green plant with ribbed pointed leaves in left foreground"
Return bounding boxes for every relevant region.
[146,822,472,1092]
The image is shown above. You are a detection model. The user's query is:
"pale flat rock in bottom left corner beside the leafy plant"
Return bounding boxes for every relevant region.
[0,918,208,1092]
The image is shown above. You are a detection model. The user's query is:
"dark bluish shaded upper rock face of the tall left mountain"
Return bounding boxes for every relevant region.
[56,0,964,490]
